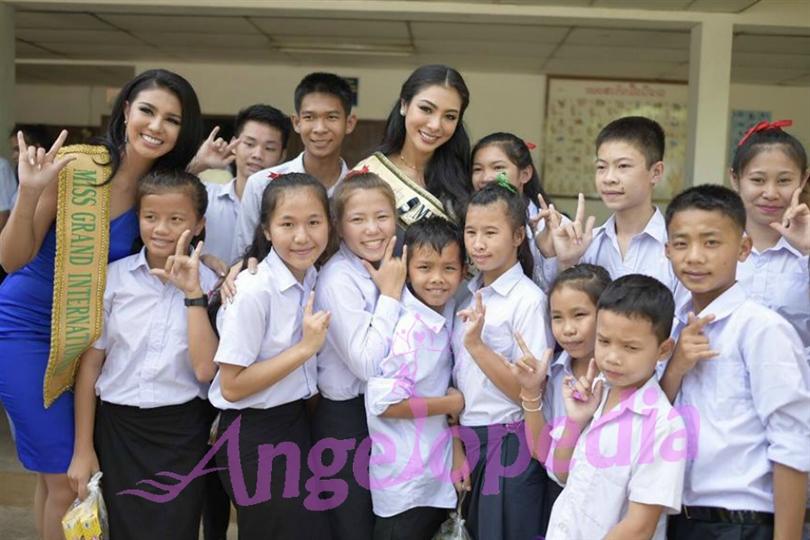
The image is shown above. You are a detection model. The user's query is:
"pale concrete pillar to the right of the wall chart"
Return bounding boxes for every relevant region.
[686,17,734,185]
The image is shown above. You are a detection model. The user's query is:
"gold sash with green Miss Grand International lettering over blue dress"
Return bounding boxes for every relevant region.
[43,145,110,407]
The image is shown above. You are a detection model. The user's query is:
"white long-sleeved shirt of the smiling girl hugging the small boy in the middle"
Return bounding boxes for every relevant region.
[315,243,401,401]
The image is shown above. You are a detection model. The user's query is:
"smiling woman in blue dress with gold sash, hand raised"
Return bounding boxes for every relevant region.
[0,70,202,540]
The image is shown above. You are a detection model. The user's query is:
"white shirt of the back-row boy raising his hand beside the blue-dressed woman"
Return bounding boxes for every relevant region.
[204,178,242,264]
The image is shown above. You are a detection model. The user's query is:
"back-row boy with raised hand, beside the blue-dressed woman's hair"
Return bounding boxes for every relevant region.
[201,104,292,264]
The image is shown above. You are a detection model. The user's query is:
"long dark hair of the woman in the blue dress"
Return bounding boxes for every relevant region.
[96,69,203,181]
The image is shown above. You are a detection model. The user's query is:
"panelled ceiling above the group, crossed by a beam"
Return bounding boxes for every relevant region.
[11,0,810,86]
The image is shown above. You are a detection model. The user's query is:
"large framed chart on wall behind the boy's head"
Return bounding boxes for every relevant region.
[543,77,688,200]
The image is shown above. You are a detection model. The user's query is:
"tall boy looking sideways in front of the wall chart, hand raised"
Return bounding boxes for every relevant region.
[538,116,685,300]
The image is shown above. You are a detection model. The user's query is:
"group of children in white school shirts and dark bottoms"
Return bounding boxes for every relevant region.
[7,64,810,540]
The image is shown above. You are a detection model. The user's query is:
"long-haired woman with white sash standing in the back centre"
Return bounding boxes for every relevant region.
[355,64,472,228]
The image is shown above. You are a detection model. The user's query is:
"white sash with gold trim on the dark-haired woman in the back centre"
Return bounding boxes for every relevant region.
[354,152,452,229]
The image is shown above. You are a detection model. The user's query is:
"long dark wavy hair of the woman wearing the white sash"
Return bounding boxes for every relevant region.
[377,64,472,217]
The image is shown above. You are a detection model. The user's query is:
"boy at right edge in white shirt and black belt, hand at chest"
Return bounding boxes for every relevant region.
[661,185,810,540]
